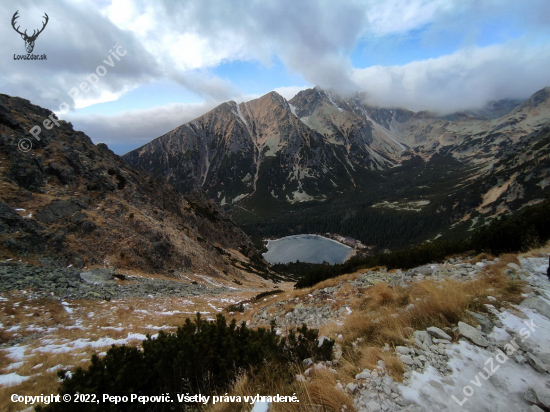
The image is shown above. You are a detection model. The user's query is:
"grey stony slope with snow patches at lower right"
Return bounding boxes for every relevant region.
[245,254,550,412]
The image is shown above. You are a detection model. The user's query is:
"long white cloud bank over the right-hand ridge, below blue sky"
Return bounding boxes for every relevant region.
[352,42,550,113]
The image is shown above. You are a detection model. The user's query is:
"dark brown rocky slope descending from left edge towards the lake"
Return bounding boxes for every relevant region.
[0,95,265,279]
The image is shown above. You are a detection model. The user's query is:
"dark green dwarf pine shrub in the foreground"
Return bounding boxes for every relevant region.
[37,314,334,412]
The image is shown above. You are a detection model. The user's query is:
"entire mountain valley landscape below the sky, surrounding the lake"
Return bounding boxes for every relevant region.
[0,78,550,412]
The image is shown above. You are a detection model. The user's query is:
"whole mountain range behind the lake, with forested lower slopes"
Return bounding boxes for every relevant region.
[123,87,550,247]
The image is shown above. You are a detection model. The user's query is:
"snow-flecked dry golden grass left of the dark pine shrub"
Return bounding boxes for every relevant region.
[0,291,274,412]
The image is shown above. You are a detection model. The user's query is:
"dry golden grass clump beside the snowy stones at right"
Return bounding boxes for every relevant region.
[330,262,523,380]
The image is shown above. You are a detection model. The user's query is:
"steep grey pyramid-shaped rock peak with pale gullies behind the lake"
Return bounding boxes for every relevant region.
[124,92,366,205]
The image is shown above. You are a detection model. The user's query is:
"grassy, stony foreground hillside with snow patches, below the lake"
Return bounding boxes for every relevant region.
[0,244,550,412]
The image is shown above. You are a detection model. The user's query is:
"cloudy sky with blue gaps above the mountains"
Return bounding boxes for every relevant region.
[0,0,550,154]
